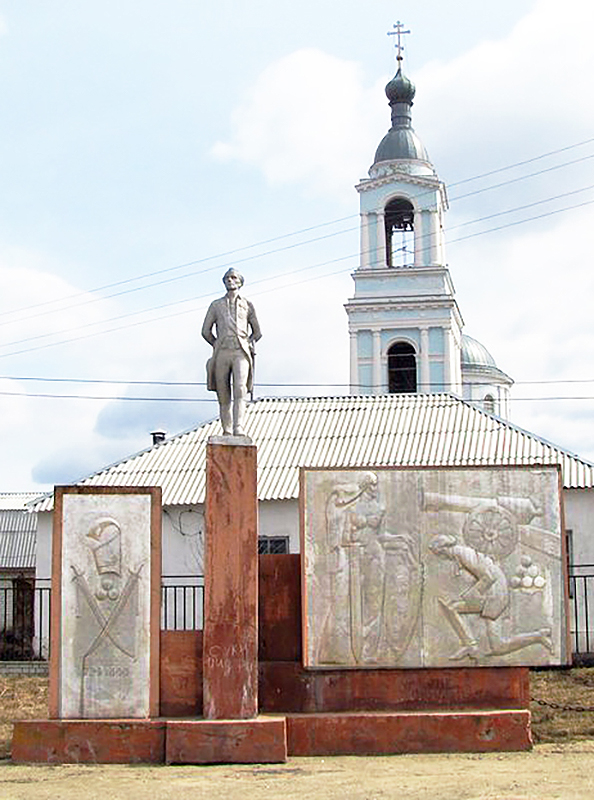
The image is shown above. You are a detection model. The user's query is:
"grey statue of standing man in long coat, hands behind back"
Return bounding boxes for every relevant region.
[202,267,262,436]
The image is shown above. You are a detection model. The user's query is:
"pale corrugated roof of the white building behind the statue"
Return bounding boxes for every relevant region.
[31,394,594,511]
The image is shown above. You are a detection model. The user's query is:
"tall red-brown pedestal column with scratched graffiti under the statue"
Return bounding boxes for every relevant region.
[203,442,258,719]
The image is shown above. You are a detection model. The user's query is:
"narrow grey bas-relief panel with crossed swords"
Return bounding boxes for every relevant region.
[60,494,151,719]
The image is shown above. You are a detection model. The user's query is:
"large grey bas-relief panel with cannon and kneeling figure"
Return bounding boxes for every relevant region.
[301,467,568,669]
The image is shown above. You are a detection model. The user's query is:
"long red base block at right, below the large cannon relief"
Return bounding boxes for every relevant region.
[287,709,532,756]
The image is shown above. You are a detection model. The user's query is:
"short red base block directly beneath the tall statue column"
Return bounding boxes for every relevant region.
[165,717,287,764]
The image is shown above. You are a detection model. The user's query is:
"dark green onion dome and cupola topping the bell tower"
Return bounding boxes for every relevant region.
[373,67,429,165]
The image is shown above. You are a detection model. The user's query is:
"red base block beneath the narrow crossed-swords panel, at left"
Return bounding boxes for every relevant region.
[12,719,166,764]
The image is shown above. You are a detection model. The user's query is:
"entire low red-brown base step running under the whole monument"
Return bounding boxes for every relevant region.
[12,709,532,764]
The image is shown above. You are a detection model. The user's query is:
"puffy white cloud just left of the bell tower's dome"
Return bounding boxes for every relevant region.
[213,49,382,197]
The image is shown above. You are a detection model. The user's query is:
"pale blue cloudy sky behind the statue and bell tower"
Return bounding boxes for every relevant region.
[0,0,594,492]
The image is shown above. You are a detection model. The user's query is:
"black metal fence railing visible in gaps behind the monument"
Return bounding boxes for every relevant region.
[0,564,594,661]
